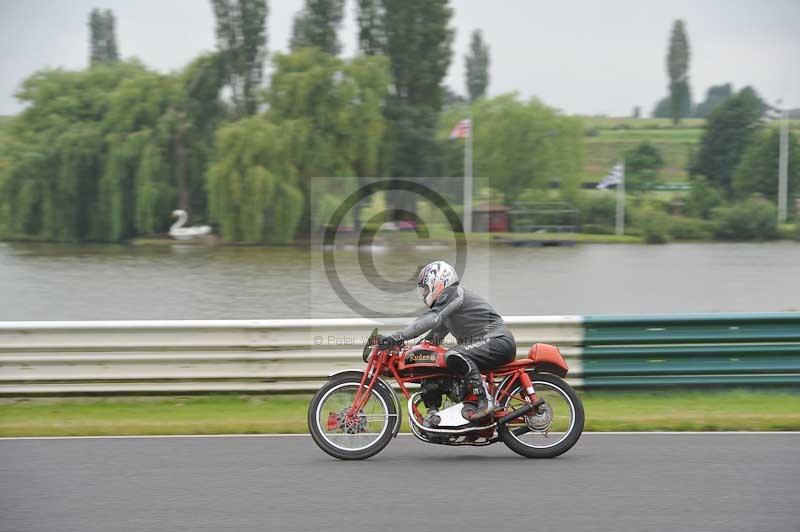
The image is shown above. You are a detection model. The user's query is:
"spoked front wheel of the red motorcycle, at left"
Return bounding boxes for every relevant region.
[308,375,400,460]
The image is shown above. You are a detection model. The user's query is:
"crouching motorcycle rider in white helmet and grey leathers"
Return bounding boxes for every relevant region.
[378,260,517,420]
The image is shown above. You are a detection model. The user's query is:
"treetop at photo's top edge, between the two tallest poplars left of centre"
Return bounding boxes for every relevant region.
[290,0,344,55]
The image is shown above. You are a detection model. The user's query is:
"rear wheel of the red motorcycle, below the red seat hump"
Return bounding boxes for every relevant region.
[498,373,585,458]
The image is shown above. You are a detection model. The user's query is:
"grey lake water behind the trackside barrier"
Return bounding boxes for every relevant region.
[0,242,800,320]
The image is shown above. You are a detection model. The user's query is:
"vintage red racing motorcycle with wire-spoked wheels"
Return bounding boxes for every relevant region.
[308,329,584,460]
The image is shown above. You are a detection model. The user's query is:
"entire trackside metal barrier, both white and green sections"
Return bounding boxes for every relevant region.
[0,313,800,396]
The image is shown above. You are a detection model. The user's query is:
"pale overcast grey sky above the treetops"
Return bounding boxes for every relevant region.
[0,0,800,116]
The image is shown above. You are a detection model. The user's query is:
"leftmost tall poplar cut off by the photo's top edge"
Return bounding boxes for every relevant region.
[211,0,268,116]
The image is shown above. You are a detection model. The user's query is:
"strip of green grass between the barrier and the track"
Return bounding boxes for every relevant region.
[0,391,800,436]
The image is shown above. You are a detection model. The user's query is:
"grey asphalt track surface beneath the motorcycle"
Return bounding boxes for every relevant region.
[0,433,800,532]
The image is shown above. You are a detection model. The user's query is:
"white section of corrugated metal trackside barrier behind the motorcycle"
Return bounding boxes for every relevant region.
[0,316,583,396]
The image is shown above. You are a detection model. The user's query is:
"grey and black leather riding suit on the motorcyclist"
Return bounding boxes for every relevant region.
[400,284,517,381]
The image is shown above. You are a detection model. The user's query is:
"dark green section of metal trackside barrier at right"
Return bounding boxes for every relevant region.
[582,313,800,389]
